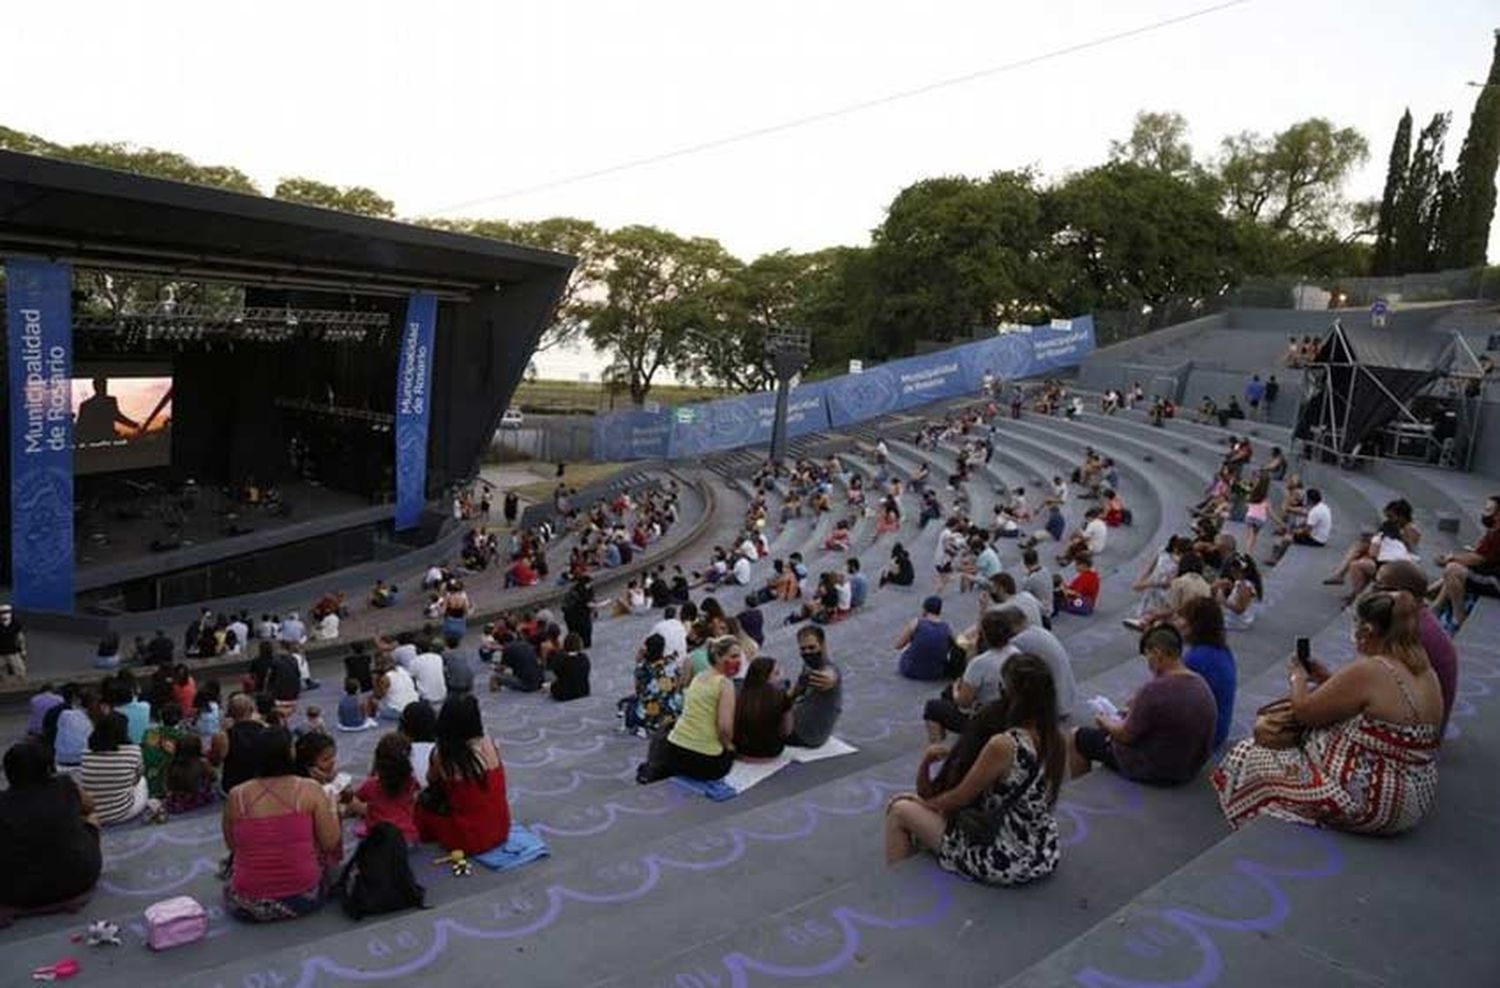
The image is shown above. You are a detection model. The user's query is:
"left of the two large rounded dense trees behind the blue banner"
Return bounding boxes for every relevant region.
[870,171,1046,358]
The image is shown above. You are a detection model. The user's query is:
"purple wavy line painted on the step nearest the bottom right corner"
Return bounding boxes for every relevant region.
[1074,826,1344,988]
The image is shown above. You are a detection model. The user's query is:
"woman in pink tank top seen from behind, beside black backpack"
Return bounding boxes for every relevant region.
[224,727,342,922]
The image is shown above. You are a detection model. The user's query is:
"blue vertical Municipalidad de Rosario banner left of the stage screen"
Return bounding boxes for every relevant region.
[6,258,74,612]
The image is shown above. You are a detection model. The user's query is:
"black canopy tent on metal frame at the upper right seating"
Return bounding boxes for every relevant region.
[1295,319,1457,459]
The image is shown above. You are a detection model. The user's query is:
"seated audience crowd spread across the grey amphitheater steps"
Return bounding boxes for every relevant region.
[0,392,1482,924]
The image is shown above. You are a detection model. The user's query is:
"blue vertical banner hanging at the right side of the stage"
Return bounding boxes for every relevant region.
[396,292,438,532]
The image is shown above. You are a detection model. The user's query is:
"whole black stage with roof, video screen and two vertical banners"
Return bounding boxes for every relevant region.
[0,151,573,637]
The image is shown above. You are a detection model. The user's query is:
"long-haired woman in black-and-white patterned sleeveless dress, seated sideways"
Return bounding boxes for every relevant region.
[885,654,1068,885]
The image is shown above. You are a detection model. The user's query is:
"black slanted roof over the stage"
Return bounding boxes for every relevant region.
[0,151,573,298]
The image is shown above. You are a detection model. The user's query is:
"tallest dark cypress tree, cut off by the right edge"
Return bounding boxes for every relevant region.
[1443,30,1500,267]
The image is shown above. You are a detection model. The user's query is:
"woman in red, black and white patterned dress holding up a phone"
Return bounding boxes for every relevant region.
[1214,592,1443,834]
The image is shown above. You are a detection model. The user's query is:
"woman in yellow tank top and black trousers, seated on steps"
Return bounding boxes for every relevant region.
[636,637,744,783]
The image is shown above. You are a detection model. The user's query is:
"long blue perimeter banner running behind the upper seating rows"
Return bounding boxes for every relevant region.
[594,316,1094,460]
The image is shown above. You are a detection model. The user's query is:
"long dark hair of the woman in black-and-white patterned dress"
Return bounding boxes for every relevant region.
[936,652,1068,807]
